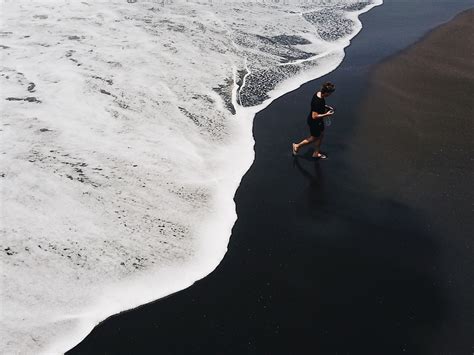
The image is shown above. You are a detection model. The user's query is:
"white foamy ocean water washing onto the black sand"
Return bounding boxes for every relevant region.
[0,0,381,354]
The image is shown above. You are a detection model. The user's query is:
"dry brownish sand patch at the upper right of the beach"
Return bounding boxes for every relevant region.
[351,10,474,242]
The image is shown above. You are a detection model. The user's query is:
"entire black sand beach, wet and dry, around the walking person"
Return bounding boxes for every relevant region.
[68,1,474,354]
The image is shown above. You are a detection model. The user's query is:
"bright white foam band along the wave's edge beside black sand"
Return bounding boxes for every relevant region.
[46,0,383,353]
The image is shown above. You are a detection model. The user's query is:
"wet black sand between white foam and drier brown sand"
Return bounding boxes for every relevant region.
[68,0,473,354]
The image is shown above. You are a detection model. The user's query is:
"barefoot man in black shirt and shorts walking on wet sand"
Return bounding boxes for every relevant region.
[293,82,336,159]
